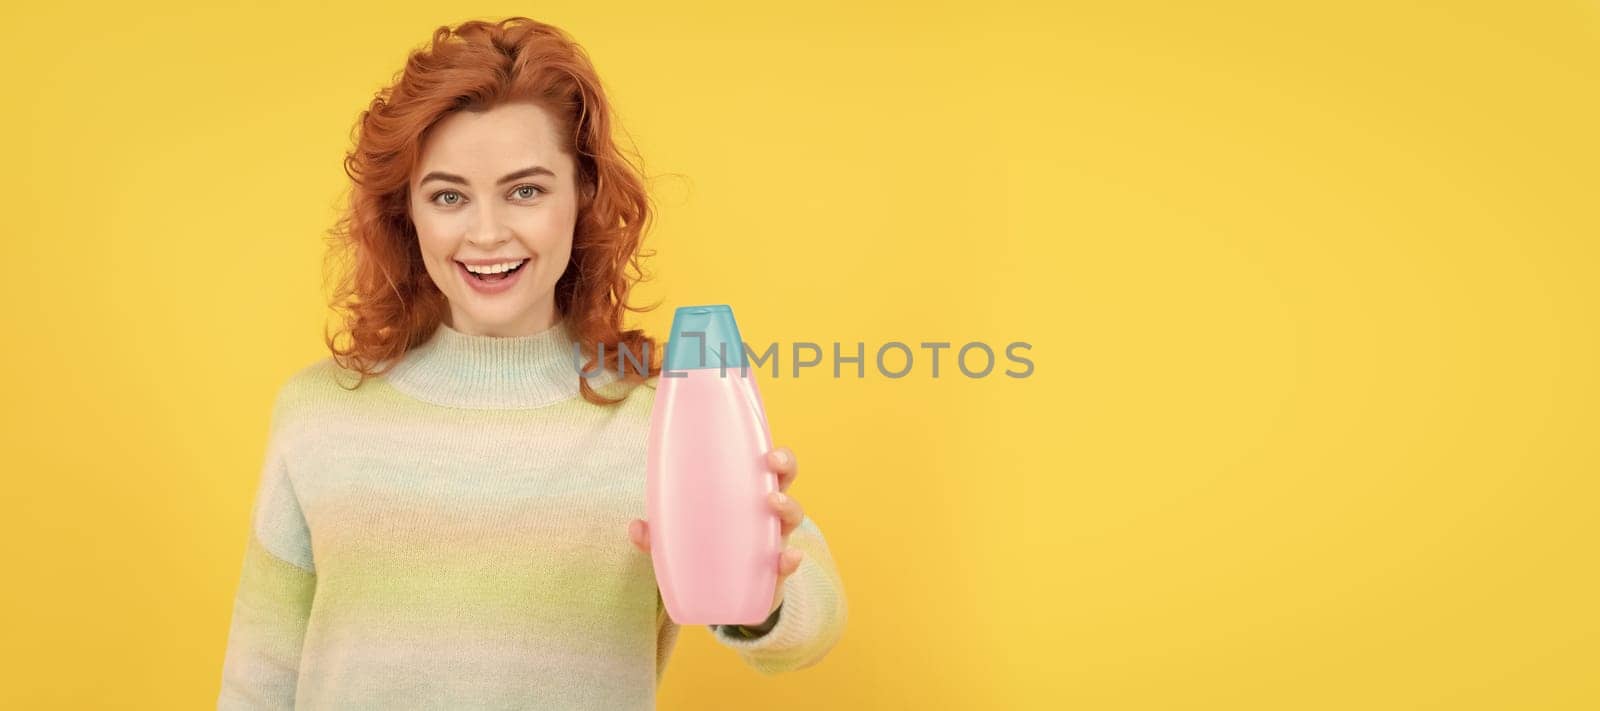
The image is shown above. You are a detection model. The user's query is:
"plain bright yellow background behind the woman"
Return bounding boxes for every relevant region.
[0,2,1600,709]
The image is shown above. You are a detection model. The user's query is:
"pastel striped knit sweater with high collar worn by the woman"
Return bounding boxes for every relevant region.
[218,323,846,709]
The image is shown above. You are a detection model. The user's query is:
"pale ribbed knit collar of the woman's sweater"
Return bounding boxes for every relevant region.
[386,320,616,410]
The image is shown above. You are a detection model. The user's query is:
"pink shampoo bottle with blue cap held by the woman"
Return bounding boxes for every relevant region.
[645,304,782,625]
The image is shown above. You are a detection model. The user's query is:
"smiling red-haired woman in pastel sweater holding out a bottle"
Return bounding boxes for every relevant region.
[218,18,846,709]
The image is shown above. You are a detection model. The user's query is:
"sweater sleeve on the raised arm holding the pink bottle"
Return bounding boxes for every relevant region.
[710,516,848,676]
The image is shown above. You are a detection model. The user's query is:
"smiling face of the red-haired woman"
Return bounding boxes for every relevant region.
[410,102,578,336]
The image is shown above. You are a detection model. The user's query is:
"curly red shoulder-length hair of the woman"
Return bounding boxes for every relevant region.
[323,16,661,405]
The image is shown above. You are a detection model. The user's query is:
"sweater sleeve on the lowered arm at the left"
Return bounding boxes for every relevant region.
[218,396,317,709]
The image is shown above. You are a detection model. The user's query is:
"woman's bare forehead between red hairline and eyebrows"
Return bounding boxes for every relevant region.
[418,102,571,175]
